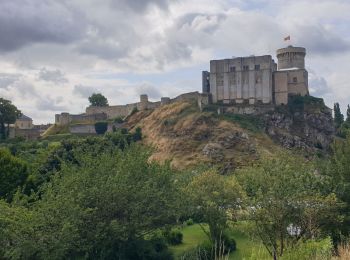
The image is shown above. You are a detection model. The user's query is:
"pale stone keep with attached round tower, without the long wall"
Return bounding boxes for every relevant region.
[202,46,309,105]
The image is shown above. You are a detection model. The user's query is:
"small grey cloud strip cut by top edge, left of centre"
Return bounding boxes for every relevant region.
[111,0,174,12]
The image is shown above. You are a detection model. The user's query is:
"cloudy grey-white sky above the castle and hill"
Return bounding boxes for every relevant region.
[0,0,350,124]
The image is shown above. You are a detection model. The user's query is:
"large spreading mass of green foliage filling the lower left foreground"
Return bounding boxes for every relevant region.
[0,146,180,259]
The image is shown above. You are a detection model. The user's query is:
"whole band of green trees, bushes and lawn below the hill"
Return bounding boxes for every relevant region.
[0,97,350,259]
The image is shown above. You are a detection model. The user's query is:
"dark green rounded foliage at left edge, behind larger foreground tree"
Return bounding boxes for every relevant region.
[0,149,28,200]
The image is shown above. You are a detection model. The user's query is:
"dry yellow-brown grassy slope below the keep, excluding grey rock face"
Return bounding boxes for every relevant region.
[127,102,288,172]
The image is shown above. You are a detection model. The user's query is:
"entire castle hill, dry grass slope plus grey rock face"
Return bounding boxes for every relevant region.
[126,96,334,173]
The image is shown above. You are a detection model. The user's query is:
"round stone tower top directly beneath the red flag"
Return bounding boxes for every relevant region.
[277,45,306,70]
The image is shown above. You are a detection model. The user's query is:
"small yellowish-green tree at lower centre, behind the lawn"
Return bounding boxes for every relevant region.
[186,171,244,243]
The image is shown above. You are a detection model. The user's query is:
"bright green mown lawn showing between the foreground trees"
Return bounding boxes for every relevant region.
[170,224,271,260]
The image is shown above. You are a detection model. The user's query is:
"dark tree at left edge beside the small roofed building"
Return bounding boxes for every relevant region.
[0,98,21,139]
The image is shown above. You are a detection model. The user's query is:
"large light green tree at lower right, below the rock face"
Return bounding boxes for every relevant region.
[238,153,339,259]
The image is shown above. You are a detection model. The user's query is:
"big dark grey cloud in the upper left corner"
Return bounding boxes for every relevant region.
[0,0,86,52]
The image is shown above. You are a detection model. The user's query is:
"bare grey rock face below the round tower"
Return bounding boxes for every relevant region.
[265,106,335,150]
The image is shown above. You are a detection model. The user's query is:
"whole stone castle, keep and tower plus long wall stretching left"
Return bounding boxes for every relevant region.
[55,46,309,133]
